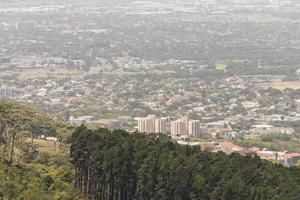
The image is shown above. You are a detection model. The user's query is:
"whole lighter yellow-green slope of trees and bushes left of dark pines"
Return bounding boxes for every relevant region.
[0,101,79,200]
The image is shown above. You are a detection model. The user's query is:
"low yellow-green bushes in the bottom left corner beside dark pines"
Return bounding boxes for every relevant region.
[0,162,76,200]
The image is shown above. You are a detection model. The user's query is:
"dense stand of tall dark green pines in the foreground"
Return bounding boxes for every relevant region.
[71,127,300,200]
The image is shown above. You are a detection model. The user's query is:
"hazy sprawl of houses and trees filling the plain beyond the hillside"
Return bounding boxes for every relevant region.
[0,0,300,164]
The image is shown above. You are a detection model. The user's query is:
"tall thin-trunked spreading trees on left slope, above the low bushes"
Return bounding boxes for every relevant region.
[0,101,67,164]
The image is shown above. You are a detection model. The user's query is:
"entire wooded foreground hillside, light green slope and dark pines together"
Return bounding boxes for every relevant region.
[0,101,300,200]
